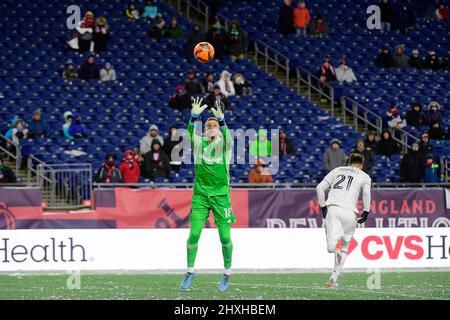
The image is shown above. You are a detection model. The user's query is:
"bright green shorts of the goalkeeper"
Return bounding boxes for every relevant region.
[189,194,236,226]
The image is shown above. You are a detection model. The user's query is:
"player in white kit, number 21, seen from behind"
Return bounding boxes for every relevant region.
[316,153,371,288]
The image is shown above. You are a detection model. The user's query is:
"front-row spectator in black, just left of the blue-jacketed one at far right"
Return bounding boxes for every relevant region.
[400,142,425,182]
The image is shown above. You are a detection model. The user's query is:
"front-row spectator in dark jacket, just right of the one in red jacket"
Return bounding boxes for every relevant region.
[143,139,170,180]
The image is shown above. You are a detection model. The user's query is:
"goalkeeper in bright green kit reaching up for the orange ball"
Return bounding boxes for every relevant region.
[181,98,236,292]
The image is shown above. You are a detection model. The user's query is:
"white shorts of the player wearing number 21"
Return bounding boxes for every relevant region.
[325,206,357,243]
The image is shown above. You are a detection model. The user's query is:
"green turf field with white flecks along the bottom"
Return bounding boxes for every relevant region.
[0,272,450,300]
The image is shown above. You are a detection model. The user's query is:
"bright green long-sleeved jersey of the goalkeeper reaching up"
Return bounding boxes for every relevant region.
[188,121,233,196]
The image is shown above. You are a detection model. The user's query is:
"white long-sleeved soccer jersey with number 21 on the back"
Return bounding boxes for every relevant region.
[323,166,372,212]
